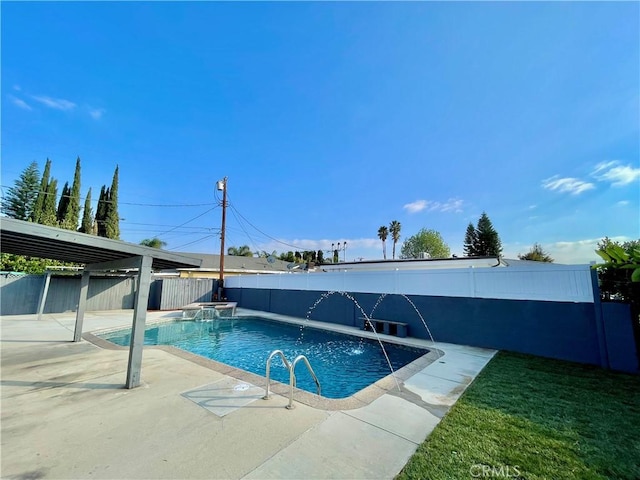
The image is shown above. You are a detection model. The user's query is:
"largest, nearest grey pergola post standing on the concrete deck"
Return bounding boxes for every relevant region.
[125,255,153,388]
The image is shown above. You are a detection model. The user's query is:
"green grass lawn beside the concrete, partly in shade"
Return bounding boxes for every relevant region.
[397,352,640,480]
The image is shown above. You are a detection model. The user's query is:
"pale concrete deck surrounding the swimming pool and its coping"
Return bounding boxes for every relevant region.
[0,309,495,480]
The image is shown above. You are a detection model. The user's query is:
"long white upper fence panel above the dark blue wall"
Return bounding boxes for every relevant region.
[226,265,593,303]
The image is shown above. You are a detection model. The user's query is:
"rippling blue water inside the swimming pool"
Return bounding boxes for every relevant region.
[101,317,428,398]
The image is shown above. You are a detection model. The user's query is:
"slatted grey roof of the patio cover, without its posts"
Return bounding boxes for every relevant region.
[0,217,202,269]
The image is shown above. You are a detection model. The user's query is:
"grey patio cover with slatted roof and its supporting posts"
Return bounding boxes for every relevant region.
[0,217,202,388]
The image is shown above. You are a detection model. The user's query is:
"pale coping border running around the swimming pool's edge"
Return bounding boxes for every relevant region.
[82,309,444,411]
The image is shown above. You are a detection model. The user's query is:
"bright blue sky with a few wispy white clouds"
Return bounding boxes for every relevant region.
[1,2,640,263]
